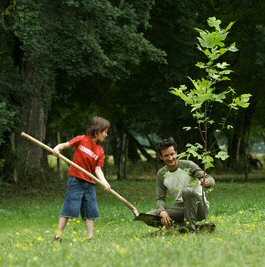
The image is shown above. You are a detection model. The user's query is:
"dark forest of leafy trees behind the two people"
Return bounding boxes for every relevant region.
[0,0,265,187]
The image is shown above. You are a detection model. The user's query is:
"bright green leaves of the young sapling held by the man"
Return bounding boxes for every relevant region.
[171,17,251,170]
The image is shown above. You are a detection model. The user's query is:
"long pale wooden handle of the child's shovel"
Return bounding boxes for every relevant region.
[21,132,139,217]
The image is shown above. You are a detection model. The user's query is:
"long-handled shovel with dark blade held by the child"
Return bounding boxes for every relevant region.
[21,132,161,227]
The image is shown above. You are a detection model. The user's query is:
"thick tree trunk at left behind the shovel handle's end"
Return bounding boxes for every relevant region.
[15,62,52,182]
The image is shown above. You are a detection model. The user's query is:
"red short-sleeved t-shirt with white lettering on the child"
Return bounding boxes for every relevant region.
[68,135,104,184]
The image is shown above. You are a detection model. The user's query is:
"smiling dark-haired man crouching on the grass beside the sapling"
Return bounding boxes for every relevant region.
[147,139,215,232]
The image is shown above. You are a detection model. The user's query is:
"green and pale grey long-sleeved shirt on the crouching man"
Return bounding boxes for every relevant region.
[156,160,215,214]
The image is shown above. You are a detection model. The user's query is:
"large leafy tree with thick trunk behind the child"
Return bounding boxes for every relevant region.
[3,0,164,184]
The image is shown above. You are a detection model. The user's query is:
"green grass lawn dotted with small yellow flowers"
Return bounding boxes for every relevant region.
[0,180,265,267]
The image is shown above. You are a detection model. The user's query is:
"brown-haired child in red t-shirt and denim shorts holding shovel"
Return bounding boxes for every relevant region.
[54,117,110,242]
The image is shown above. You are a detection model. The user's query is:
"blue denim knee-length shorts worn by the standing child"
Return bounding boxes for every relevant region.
[61,176,99,220]
